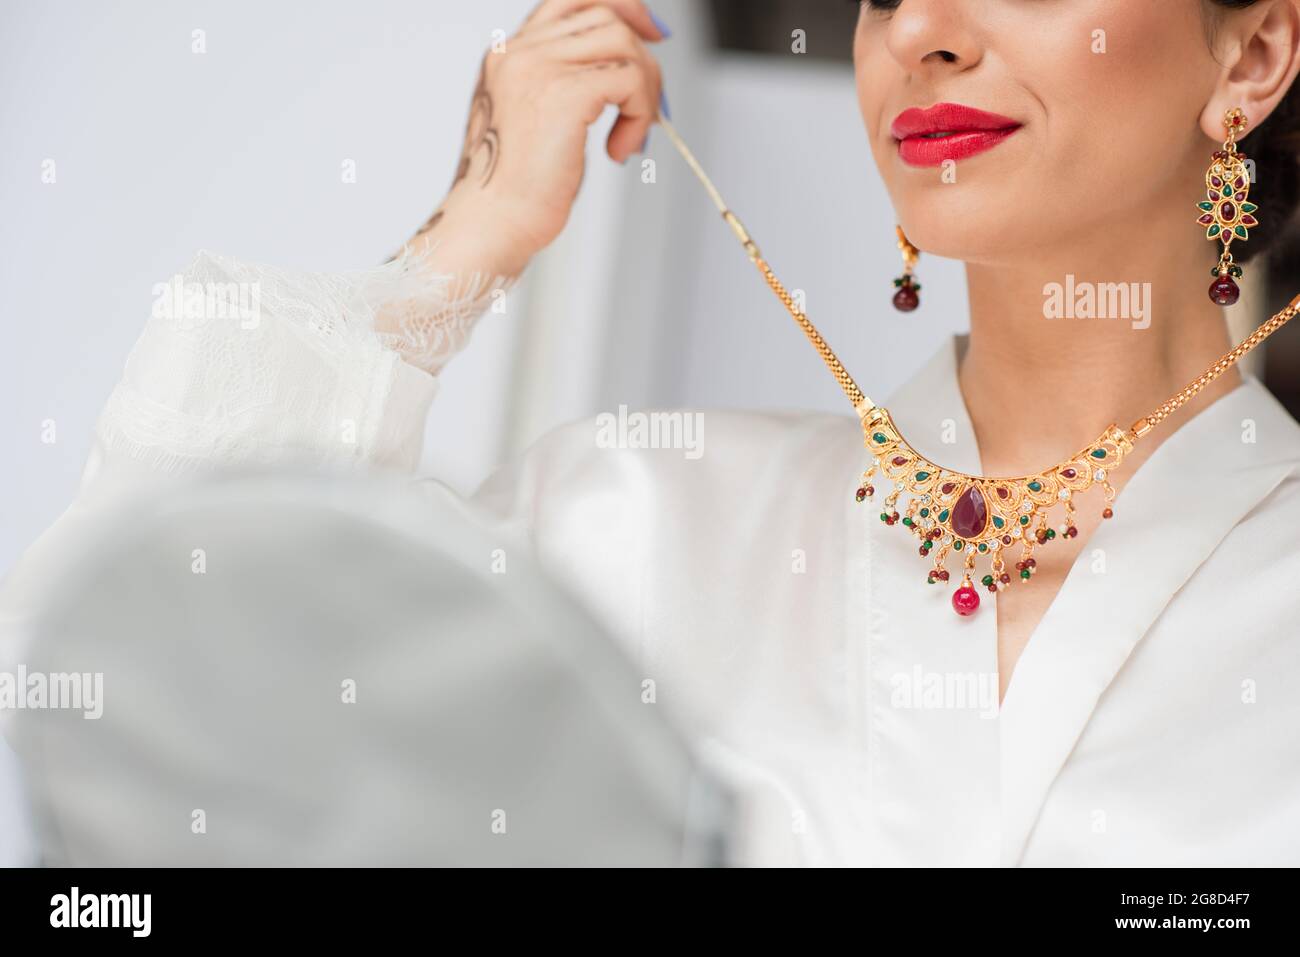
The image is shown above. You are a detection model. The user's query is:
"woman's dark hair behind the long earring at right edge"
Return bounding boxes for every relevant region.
[1206,0,1300,263]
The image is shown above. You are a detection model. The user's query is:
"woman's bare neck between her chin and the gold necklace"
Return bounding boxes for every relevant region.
[959,214,1240,475]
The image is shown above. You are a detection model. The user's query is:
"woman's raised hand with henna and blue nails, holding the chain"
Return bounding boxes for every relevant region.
[411,0,666,276]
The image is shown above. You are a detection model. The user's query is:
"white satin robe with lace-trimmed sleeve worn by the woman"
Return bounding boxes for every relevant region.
[0,254,1300,866]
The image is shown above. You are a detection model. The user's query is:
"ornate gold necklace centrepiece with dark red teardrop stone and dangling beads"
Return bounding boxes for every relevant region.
[857,407,1136,618]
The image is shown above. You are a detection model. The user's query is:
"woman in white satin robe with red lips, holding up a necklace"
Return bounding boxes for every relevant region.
[9,0,1300,865]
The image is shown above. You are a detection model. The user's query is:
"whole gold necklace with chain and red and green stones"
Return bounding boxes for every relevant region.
[659,117,1300,615]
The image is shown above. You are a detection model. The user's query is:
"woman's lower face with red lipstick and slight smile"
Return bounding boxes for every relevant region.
[854,0,1222,263]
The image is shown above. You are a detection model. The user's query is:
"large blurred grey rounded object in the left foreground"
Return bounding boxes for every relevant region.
[9,475,732,866]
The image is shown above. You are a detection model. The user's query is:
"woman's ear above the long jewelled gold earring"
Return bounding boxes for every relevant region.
[1201,0,1300,142]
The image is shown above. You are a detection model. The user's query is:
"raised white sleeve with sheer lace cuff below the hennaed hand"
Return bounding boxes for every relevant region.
[86,252,512,481]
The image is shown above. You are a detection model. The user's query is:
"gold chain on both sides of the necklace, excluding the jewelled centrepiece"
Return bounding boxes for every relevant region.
[659,116,1300,438]
